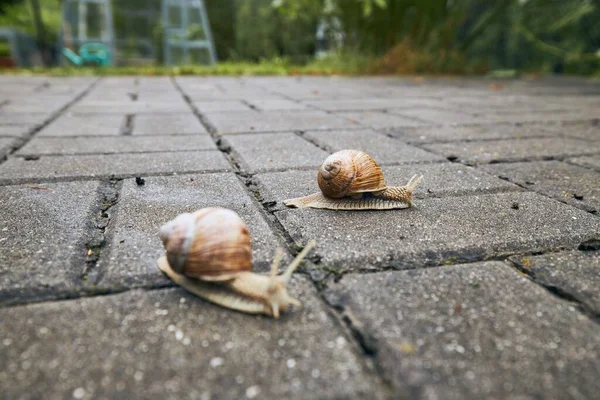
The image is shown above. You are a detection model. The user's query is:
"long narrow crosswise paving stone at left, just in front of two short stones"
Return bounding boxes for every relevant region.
[17,135,217,156]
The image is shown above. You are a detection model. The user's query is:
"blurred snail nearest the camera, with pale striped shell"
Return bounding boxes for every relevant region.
[157,207,315,318]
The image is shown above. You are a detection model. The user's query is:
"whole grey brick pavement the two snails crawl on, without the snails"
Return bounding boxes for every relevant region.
[0,76,600,399]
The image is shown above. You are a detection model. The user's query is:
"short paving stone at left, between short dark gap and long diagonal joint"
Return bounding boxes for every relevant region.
[133,112,207,135]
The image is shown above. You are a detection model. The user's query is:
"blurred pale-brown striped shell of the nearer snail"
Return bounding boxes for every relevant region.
[160,207,252,281]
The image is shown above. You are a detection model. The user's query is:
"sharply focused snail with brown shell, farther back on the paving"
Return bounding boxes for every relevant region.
[283,150,423,210]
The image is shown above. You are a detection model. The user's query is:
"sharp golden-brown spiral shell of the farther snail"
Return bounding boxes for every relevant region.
[317,150,386,199]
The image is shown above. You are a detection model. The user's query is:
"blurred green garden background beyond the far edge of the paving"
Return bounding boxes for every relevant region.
[0,0,600,76]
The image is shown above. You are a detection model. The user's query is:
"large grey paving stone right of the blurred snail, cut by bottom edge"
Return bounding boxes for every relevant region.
[329,262,600,400]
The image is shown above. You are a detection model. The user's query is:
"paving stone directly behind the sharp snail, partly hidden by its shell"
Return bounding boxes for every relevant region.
[304,129,444,164]
